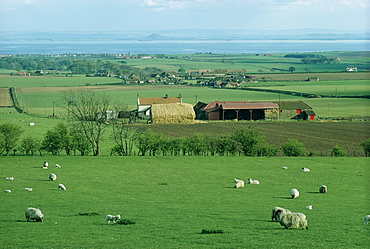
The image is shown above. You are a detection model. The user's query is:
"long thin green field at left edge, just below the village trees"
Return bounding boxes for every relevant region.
[0,75,122,87]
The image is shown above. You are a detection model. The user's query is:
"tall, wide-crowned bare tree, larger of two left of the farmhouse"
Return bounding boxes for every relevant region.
[62,88,110,156]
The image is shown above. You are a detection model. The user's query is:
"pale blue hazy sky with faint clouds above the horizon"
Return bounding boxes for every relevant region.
[0,0,370,31]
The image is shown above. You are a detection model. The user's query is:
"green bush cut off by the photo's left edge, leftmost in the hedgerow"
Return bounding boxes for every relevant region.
[0,123,23,156]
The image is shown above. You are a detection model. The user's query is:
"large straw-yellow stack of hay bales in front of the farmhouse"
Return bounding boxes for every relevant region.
[151,103,195,124]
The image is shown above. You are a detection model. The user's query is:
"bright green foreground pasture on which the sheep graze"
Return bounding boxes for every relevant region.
[0,156,370,248]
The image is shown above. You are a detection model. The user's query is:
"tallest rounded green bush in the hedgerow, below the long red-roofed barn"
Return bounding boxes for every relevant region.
[232,127,265,156]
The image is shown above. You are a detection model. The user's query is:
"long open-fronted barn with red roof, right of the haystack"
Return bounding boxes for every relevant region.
[194,101,279,120]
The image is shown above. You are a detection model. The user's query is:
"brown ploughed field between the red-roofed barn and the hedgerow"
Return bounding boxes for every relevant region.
[139,121,370,156]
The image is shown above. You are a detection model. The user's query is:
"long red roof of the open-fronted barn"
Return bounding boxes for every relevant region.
[203,101,279,111]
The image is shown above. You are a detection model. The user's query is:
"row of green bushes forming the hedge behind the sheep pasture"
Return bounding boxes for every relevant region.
[0,121,370,156]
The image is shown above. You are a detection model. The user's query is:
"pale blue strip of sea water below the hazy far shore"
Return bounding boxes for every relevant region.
[0,40,370,55]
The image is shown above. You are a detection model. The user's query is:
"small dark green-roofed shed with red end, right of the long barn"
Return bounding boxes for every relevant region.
[274,101,316,120]
